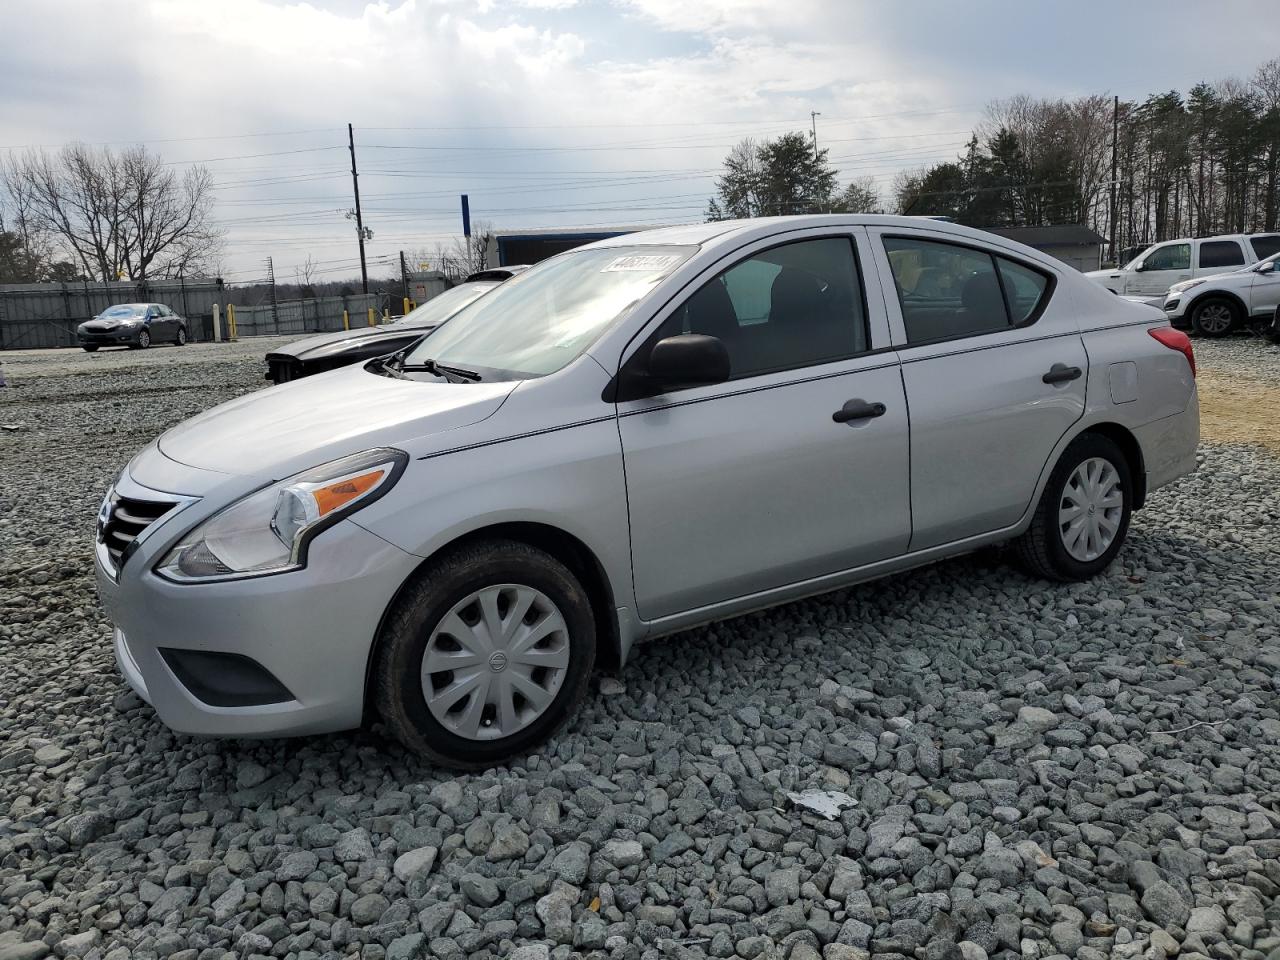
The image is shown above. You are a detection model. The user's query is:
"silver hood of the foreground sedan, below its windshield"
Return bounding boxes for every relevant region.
[157,365,516,480]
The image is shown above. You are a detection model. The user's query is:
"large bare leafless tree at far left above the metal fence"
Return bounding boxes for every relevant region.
[4,143,221,282]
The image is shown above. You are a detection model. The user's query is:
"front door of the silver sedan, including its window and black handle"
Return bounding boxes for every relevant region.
[618,232,910,621]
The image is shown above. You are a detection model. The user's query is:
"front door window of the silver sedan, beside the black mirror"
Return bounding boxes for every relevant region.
[657,237,867,380]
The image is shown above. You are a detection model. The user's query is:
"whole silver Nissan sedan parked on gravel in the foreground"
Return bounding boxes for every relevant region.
[97,215,1199,767]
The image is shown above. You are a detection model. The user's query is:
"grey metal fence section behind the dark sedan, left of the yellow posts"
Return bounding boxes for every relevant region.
[0,280,227,349]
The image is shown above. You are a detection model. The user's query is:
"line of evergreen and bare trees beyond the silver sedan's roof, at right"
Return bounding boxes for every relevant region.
[707,58,1280,261]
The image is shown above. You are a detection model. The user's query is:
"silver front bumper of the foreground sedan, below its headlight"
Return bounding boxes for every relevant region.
[95,477,420,736]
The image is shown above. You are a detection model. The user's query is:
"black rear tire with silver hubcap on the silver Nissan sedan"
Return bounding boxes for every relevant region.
[1014,433,1133,582]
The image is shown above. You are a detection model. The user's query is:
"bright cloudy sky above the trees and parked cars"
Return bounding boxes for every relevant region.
[0,0,1280,282]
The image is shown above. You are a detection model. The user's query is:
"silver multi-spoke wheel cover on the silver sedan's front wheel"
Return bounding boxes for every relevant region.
[421,584,570,740]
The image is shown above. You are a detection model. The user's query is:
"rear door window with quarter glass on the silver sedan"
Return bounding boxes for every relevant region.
[884,237,1050,343]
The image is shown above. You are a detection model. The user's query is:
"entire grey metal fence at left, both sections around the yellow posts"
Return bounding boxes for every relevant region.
[0,280,386,349]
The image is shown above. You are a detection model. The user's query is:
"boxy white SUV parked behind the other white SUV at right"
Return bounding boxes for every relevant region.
[1084,233,1280,300]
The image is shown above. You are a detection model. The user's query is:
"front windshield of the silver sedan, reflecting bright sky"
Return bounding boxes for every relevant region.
[404,246,695,380]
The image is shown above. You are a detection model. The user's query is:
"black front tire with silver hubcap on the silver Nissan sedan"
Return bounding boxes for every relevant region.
[372,540,595,769]
